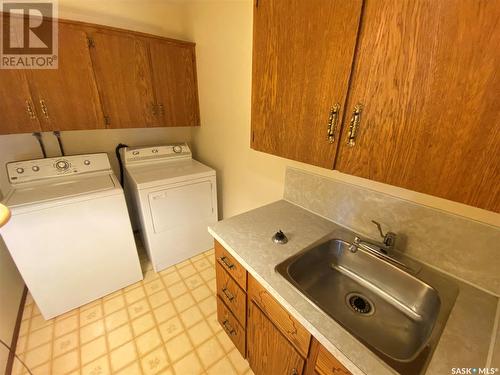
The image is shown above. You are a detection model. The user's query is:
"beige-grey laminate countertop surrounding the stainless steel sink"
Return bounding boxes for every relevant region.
[208,200,500,375]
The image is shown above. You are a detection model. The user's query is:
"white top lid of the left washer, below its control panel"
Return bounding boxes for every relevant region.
[4,173,116,208]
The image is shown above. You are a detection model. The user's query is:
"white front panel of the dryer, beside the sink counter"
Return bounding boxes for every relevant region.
[140,176,217,272]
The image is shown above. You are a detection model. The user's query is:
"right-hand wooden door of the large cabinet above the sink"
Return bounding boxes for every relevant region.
[336,0,500,212]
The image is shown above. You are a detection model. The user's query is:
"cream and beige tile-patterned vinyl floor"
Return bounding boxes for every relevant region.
[12,241,253,375]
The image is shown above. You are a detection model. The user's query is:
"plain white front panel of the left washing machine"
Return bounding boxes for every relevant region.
[0,194,143,319]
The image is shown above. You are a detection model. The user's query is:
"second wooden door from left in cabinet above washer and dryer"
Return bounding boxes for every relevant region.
[27,22,104,131]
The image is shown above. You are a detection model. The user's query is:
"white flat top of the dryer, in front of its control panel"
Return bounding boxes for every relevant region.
[127,159,215,189]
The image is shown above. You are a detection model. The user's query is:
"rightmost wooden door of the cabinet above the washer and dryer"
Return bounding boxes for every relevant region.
[149,38,200,126]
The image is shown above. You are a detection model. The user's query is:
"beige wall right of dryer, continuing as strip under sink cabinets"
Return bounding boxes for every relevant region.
[186,0,500,226]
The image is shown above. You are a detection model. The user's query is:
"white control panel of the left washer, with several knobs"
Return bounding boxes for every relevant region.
[7,153,111,184]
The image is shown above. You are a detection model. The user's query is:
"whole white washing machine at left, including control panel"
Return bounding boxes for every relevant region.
[0,154,142,319]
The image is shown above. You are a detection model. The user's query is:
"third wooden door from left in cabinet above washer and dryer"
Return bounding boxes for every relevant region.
[90,30,156,128]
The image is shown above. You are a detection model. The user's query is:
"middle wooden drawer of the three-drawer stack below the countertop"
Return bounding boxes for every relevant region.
[215,263,247,327]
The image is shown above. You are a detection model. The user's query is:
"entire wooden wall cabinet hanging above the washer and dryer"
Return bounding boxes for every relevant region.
[0,13,200,134]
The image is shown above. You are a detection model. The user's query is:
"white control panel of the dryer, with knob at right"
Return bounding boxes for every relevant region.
[122,143,192,164]
